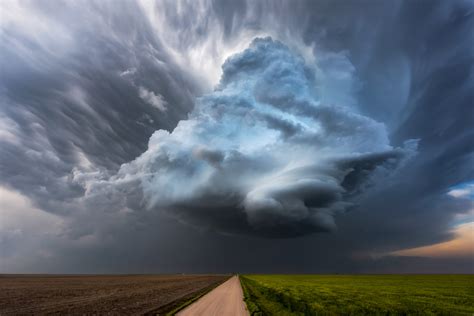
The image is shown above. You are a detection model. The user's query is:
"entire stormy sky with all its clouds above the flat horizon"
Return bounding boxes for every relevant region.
[0,0,474,273]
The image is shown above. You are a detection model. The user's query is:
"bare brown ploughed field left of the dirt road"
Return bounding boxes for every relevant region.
[0,275,229,315]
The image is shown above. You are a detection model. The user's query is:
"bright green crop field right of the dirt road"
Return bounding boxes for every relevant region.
[240,275,474,315]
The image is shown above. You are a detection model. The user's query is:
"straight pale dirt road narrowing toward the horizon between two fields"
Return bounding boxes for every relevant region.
[177,276,249,316]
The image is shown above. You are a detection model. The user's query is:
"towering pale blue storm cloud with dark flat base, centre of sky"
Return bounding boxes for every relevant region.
[81,38,416,237]
